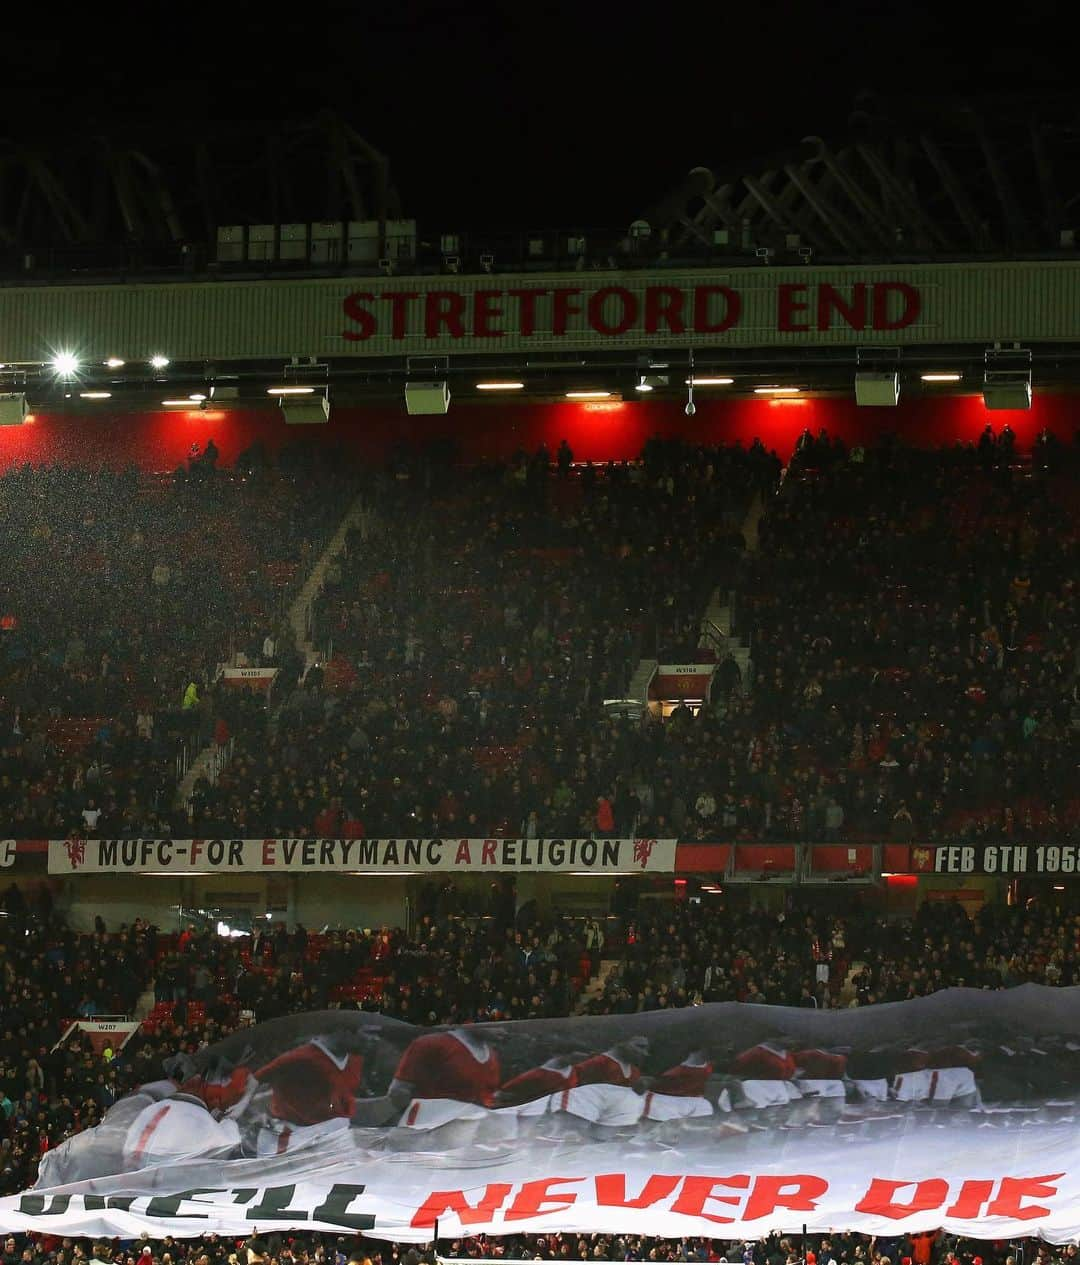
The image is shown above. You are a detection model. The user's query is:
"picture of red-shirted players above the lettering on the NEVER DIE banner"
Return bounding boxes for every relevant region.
[21,986,1042,1185]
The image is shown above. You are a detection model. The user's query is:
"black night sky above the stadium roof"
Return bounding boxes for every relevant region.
[0,0,1072,228]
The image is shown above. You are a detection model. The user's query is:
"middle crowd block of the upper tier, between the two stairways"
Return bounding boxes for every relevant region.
[196,441,778,836]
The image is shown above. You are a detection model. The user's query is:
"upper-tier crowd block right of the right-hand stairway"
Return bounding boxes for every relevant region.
[733,436,1080,841]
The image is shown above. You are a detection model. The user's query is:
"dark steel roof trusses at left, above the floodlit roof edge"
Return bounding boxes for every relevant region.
[0,113,397,263]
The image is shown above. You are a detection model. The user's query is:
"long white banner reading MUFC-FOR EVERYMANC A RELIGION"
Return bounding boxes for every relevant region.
[49,839,678,874]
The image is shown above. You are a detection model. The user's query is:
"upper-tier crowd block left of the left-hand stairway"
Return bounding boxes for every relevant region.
[0,452,349,837]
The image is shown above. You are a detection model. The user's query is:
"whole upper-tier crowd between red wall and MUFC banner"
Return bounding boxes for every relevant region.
[0,436,1080,841]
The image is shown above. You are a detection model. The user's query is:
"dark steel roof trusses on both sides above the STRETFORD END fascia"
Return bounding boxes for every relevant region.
[0,97,1080,280]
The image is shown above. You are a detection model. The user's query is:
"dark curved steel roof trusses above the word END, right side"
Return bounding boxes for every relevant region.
[645,97,1080,261]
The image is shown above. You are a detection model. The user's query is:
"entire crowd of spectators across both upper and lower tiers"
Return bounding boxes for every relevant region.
[0,436,1080,1265]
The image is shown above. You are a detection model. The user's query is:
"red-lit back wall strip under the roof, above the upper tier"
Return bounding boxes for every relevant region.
[8,393,1080,471]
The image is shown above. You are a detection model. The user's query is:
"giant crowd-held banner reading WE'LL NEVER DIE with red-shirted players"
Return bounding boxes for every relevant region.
[0,985,1080,1242]
